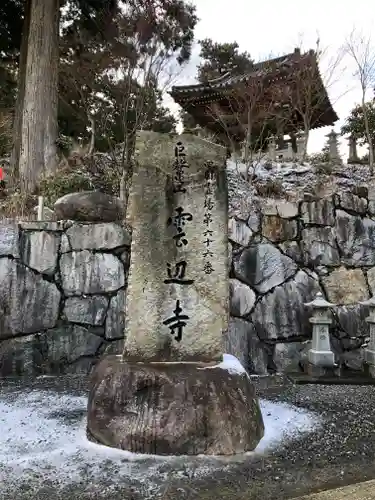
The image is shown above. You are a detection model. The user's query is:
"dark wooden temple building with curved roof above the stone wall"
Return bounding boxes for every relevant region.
[170,49,338,156]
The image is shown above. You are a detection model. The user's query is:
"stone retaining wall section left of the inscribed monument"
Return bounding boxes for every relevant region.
[0,222,130,376]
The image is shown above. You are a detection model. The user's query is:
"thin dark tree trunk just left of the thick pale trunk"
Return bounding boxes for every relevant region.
[10,0,31,182]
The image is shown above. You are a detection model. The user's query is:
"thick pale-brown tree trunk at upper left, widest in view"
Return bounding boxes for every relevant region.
[19,0,60,192]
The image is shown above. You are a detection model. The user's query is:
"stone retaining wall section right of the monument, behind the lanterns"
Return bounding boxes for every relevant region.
[227,189,375,374]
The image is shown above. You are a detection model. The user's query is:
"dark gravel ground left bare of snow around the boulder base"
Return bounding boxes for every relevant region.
[0,376,375,500]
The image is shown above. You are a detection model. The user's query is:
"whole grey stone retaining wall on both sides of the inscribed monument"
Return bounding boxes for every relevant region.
[0,179,375,375]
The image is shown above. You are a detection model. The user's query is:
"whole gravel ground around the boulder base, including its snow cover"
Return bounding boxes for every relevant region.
[0,377,375,500]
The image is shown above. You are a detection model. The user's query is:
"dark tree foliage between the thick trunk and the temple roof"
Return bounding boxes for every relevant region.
[59,0,197,151]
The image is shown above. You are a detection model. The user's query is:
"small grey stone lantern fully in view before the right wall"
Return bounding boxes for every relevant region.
[304,292,336,368]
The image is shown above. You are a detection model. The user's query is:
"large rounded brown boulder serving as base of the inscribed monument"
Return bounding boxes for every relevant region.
[87,356,264,455]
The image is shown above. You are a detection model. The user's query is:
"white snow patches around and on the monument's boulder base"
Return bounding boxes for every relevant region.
[0,386,320,492]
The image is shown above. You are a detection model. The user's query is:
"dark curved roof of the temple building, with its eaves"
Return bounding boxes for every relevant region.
[170,49,338,139]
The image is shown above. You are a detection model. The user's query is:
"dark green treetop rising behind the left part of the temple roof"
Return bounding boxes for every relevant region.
[198,38,253,82]
